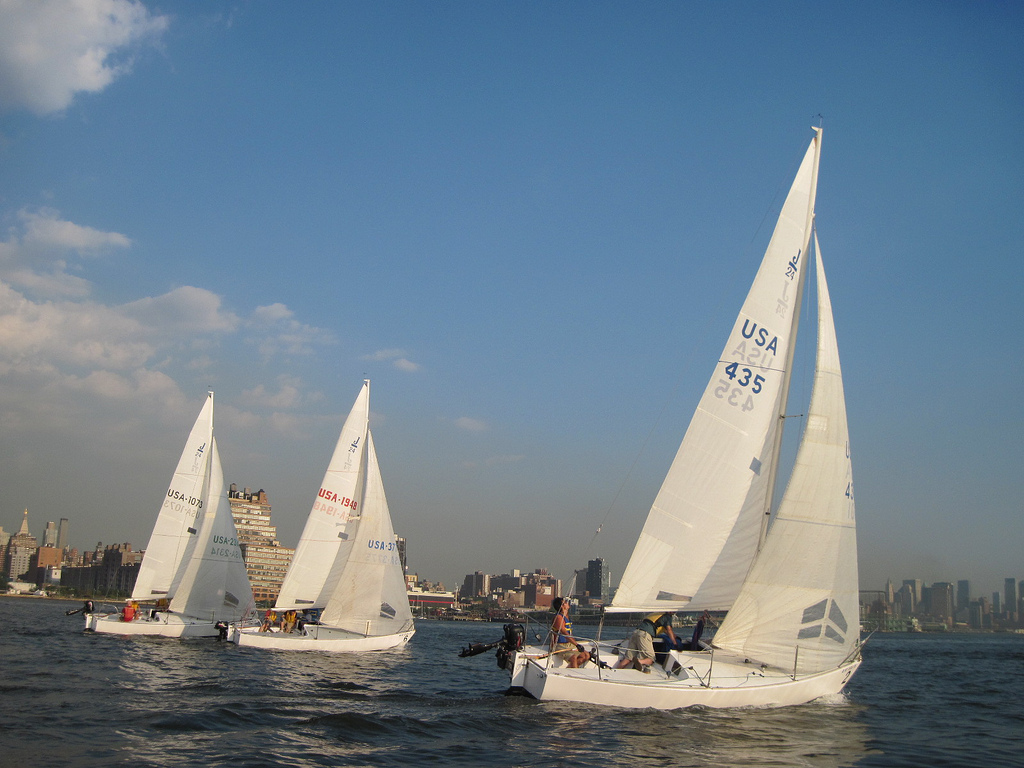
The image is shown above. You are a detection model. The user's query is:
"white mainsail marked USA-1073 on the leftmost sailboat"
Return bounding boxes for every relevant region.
[132,392,213,600]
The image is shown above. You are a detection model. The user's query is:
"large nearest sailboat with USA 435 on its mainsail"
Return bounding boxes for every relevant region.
[491,128,861,710]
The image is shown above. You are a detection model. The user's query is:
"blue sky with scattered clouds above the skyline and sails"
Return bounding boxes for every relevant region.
[0,0,1024,595]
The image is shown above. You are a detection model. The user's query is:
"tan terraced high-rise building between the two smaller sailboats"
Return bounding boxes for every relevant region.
[227,482,295,604]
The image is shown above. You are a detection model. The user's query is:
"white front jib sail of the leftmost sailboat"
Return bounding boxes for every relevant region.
[170,439,253,622]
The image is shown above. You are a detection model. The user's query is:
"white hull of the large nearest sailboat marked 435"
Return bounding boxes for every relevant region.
[511,648,860,710]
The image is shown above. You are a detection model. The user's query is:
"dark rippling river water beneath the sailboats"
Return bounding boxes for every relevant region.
[0,598,1024,768]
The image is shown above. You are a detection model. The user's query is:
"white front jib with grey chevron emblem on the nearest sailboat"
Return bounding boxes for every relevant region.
[715,234,860,675]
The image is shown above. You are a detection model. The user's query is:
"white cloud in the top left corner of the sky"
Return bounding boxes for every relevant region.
[0,0,169,115]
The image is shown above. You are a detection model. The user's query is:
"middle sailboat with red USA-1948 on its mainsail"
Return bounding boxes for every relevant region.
[230,381,415,651]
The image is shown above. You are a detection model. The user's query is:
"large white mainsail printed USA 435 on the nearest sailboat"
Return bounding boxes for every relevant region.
[609,132,820,611]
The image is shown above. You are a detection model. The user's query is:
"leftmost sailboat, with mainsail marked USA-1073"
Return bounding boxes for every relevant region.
[86,392,253,637]
